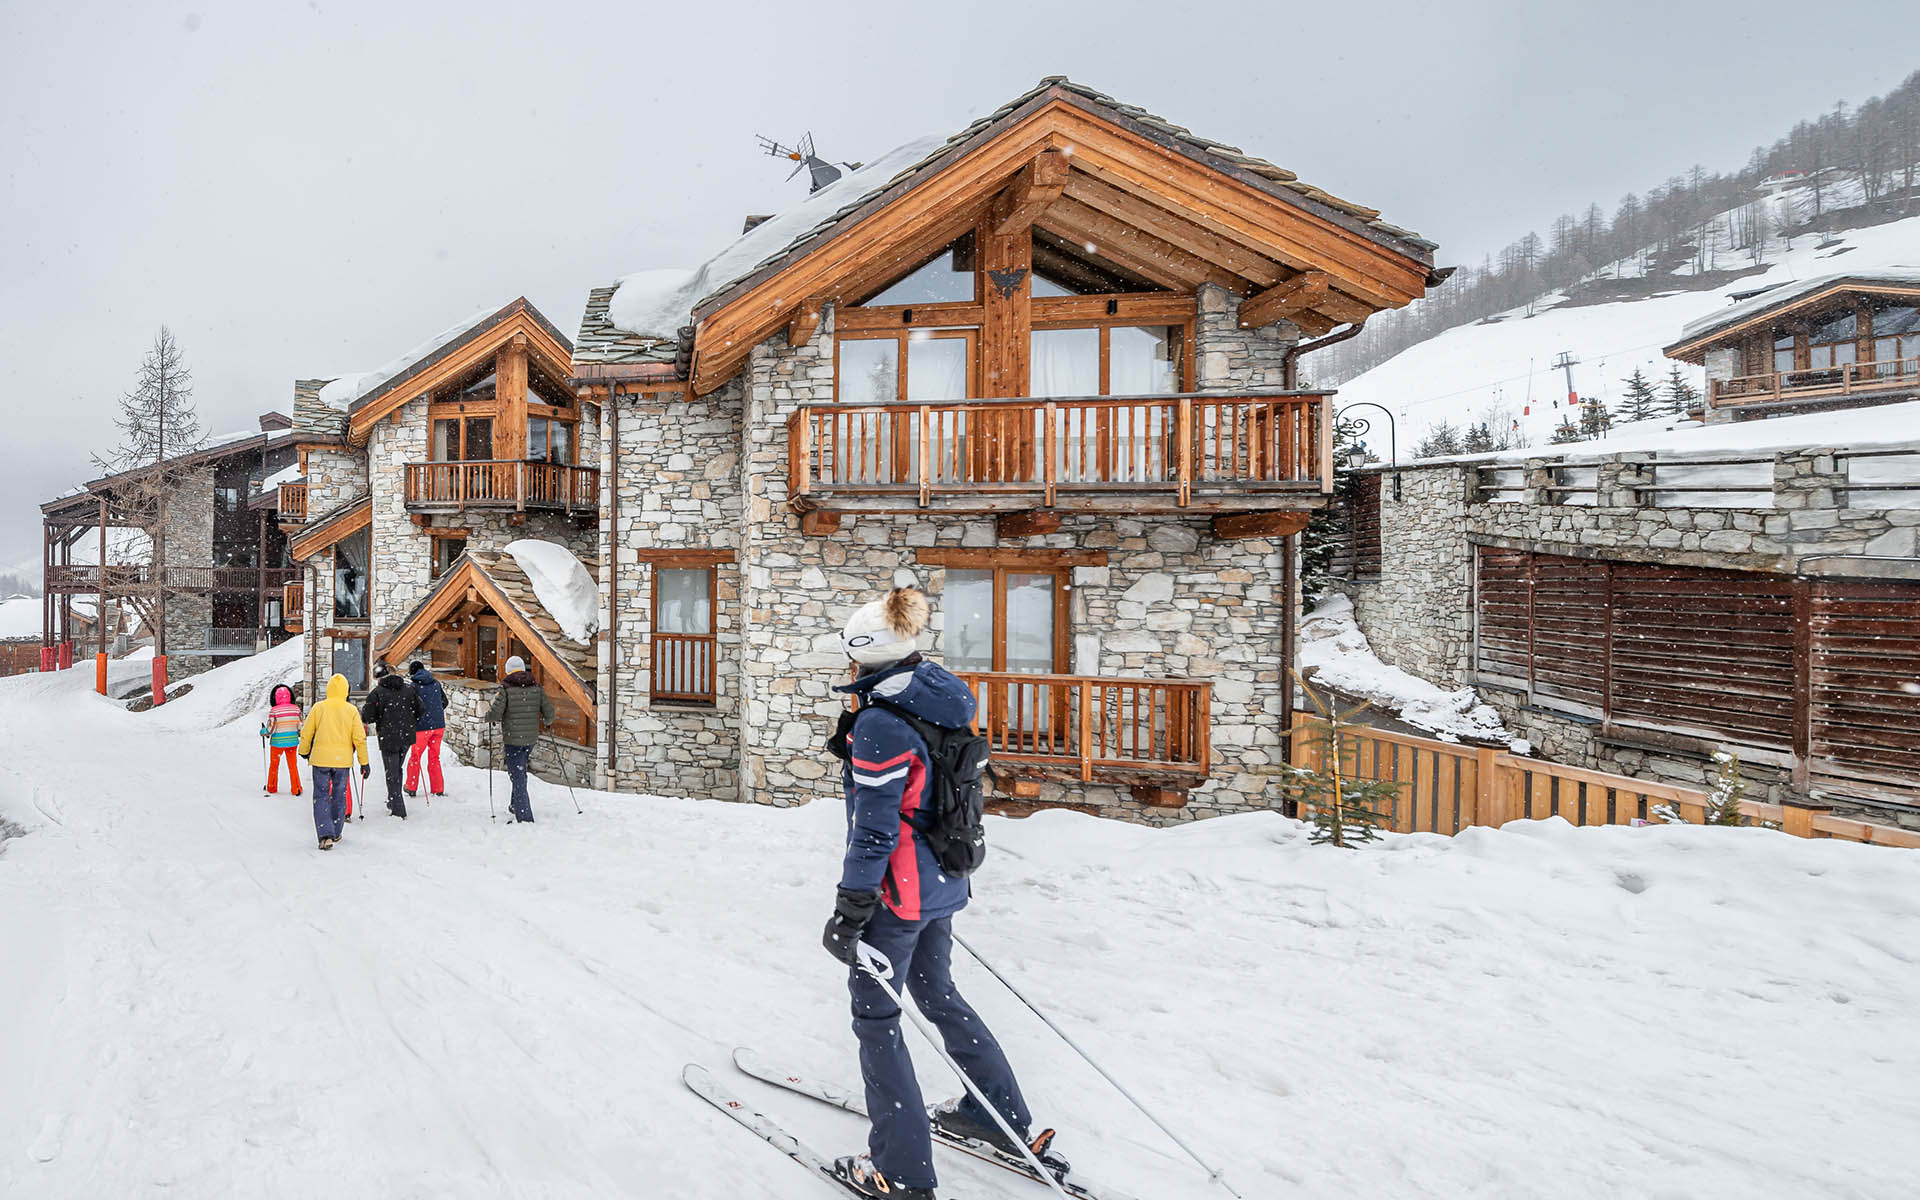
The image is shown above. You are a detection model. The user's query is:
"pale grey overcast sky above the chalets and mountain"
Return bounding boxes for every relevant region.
[0,0,1920,572]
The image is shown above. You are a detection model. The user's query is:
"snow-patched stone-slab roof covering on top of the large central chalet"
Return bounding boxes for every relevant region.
[574,77,1450,385]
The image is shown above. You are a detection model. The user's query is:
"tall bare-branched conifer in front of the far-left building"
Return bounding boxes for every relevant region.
[94,324,205,655]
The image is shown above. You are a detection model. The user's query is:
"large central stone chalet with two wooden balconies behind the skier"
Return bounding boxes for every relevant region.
[576,79,1446,820]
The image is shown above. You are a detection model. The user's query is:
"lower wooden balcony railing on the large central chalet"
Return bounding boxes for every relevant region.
[956,670,1213,781]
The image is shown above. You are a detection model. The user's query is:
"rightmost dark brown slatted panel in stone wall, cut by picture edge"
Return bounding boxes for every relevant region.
[1809,580,1920,789]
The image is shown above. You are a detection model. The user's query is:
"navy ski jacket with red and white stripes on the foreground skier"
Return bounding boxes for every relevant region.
[835,659,973,922]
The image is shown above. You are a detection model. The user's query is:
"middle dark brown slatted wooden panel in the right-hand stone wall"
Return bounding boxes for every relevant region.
[1609,563,1793,751]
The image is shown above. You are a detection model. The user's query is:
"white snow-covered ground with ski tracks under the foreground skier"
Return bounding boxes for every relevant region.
[0,641,1920,1200]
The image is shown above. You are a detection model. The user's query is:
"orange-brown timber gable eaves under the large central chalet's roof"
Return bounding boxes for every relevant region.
[691,86,1442,394]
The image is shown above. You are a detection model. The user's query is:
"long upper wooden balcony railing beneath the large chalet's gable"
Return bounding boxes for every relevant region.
[787,392,1332,515]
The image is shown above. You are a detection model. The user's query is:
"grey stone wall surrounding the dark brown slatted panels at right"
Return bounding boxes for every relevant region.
[1340,444,1920,820]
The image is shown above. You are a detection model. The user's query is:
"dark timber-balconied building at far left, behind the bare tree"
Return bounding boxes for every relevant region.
[40,413,294,678]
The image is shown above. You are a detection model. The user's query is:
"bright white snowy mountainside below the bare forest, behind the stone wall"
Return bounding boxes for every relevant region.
[1338,208,1920,459]
